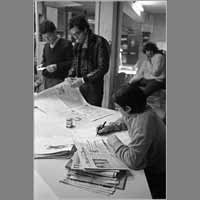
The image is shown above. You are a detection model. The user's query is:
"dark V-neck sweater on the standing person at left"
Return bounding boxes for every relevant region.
[42,38,73,80]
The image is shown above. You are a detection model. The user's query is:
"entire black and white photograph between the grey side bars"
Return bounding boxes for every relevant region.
[32,0,167,200]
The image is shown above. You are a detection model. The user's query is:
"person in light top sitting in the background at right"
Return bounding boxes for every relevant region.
[129,42,166,97]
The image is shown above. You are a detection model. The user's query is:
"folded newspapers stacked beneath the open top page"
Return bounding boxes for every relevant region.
[60,152,127,195]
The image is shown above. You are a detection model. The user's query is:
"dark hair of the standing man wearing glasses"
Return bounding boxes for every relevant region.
[69,15,90,31]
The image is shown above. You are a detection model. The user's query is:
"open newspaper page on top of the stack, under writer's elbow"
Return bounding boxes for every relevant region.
[74,138,129,170]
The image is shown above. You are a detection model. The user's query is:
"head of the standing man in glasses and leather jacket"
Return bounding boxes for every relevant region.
[69,15,90,43]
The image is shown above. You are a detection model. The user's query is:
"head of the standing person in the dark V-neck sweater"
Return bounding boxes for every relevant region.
[39,20,57,44]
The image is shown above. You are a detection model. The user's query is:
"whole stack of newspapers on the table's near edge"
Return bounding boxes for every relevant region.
[60,140,128,195]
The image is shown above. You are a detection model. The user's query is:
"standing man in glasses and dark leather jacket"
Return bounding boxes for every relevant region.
[67,16,110,106]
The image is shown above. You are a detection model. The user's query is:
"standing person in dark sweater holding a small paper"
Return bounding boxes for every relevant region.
[39,20,73,89]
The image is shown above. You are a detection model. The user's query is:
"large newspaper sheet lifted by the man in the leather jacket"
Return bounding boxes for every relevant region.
[34,81,116,123]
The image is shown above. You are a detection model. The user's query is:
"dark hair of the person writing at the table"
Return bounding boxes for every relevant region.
[112,84,146,113]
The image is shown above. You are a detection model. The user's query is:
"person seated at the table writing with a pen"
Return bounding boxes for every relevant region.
[97,84,166,198]
